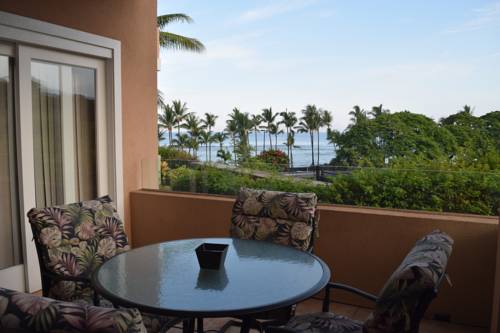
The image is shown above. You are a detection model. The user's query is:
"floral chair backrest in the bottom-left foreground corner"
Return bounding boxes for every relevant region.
[0,288,146,333]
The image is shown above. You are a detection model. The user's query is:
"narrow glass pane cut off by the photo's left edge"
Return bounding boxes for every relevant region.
[0,56,22,269]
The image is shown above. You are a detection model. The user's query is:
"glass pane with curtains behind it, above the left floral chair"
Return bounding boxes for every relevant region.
[31,61,97,207]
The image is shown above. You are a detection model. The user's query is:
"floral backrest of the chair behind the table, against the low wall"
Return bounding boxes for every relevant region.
[230,188,319,251]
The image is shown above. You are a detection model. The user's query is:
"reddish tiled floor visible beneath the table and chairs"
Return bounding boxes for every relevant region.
[193,300,488,333]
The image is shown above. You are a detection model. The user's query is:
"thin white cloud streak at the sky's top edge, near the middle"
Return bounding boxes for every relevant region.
[238,0,317,22]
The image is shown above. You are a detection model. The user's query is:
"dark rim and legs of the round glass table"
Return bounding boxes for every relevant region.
[91,239,331,333]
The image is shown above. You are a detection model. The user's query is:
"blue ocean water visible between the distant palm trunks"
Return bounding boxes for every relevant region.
[160,132,335,167]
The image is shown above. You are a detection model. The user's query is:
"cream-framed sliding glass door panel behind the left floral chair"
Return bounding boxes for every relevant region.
[17,45,112,290]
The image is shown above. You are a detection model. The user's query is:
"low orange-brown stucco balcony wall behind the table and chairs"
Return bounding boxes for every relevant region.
[131,191,498,327]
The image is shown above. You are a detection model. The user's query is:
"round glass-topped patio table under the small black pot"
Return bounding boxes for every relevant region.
[93,238,330,331]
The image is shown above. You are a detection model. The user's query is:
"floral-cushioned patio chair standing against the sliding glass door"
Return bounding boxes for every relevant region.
[28,196,180,333]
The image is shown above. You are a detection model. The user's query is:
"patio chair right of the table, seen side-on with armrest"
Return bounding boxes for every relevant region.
[267,231,453,333]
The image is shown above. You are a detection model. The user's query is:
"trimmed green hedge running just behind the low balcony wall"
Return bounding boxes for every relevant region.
[169,167,500,215]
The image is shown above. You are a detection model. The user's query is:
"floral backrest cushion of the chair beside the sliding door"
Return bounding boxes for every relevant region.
[28,196,129,286]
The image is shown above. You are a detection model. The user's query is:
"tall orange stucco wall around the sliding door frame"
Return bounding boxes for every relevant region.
[0,0,158,236]
